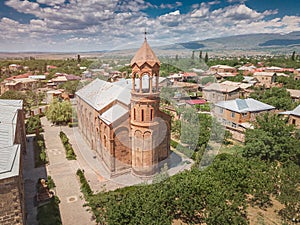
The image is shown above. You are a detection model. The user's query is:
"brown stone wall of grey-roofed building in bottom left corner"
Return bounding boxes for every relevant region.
[0,176,24,225]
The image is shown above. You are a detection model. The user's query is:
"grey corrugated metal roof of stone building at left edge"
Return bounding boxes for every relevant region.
[0,99,23,179]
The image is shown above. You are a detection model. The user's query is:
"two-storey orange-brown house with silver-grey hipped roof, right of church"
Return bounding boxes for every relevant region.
[213,98,275,142]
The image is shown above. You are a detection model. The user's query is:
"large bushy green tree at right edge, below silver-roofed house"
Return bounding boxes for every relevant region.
[243,113,300,165]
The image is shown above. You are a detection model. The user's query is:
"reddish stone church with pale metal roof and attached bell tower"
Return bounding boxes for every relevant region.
[76,37,171,177]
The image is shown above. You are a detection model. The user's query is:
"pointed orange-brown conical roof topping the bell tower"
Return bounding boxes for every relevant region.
[130,38,160,67]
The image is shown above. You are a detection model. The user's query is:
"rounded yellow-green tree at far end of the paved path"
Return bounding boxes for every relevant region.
[46,98,72,124]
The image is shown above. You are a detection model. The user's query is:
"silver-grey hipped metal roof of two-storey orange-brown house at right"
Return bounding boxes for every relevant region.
[215,98,275,113]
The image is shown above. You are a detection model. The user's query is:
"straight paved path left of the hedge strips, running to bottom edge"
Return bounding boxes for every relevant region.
[42,118,95,225]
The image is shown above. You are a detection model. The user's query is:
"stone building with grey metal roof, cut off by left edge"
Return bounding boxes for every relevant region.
[0,99,26,225]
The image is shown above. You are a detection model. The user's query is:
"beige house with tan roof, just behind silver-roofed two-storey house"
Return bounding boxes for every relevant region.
[202,83,241,103]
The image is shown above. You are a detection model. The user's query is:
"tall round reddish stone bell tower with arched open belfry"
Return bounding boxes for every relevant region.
[130,37,170,176]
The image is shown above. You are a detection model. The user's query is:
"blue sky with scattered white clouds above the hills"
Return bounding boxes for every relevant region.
[0,0,300,52]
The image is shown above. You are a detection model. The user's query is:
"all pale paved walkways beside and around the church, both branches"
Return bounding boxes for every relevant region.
[42,117,190,225]
